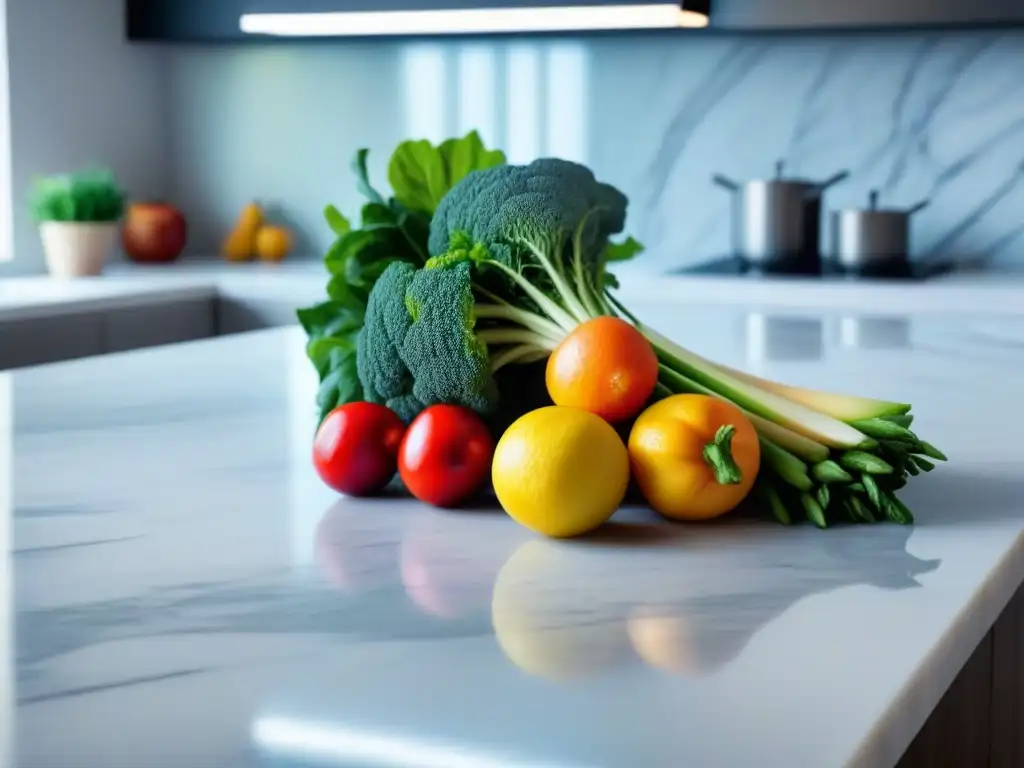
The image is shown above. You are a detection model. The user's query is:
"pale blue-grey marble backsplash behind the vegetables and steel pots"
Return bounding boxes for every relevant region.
[169,31,1024,271]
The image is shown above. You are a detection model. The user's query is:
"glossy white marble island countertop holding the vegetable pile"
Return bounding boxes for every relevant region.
[8,308,1024,768]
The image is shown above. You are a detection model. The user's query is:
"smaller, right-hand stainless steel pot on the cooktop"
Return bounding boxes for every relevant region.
[831,189,928,269]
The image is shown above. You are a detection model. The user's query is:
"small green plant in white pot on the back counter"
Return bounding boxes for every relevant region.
[30,171,125,280]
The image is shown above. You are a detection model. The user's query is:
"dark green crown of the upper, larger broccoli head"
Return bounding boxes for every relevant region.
[428,158,629,264]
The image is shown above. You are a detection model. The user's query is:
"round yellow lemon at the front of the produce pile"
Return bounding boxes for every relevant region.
[490,406,630,538]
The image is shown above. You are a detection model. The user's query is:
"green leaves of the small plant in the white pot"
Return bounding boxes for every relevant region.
[29,170,126,223]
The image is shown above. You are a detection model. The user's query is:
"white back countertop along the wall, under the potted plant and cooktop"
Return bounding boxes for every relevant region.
[0,258,1024,321]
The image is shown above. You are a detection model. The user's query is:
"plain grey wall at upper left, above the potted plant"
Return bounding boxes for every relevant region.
[0,0,167,274]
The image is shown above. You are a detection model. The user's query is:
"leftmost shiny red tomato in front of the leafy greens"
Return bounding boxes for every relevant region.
[313,402,406,496]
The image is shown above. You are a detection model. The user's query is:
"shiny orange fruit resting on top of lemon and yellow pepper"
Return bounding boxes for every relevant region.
[547,317,657,422]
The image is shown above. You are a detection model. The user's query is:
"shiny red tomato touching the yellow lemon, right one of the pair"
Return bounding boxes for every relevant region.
[398,406,495,507]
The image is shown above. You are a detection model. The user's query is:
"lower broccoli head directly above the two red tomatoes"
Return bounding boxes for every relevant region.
[356,261,498,422]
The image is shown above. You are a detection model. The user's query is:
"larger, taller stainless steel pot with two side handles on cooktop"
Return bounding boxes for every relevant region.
[712,161,850,266]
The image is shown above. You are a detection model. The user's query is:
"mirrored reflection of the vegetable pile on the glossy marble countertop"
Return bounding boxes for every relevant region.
[315,500,939,681]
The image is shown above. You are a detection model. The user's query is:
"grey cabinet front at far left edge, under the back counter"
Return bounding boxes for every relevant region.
[0,313,103,370]
